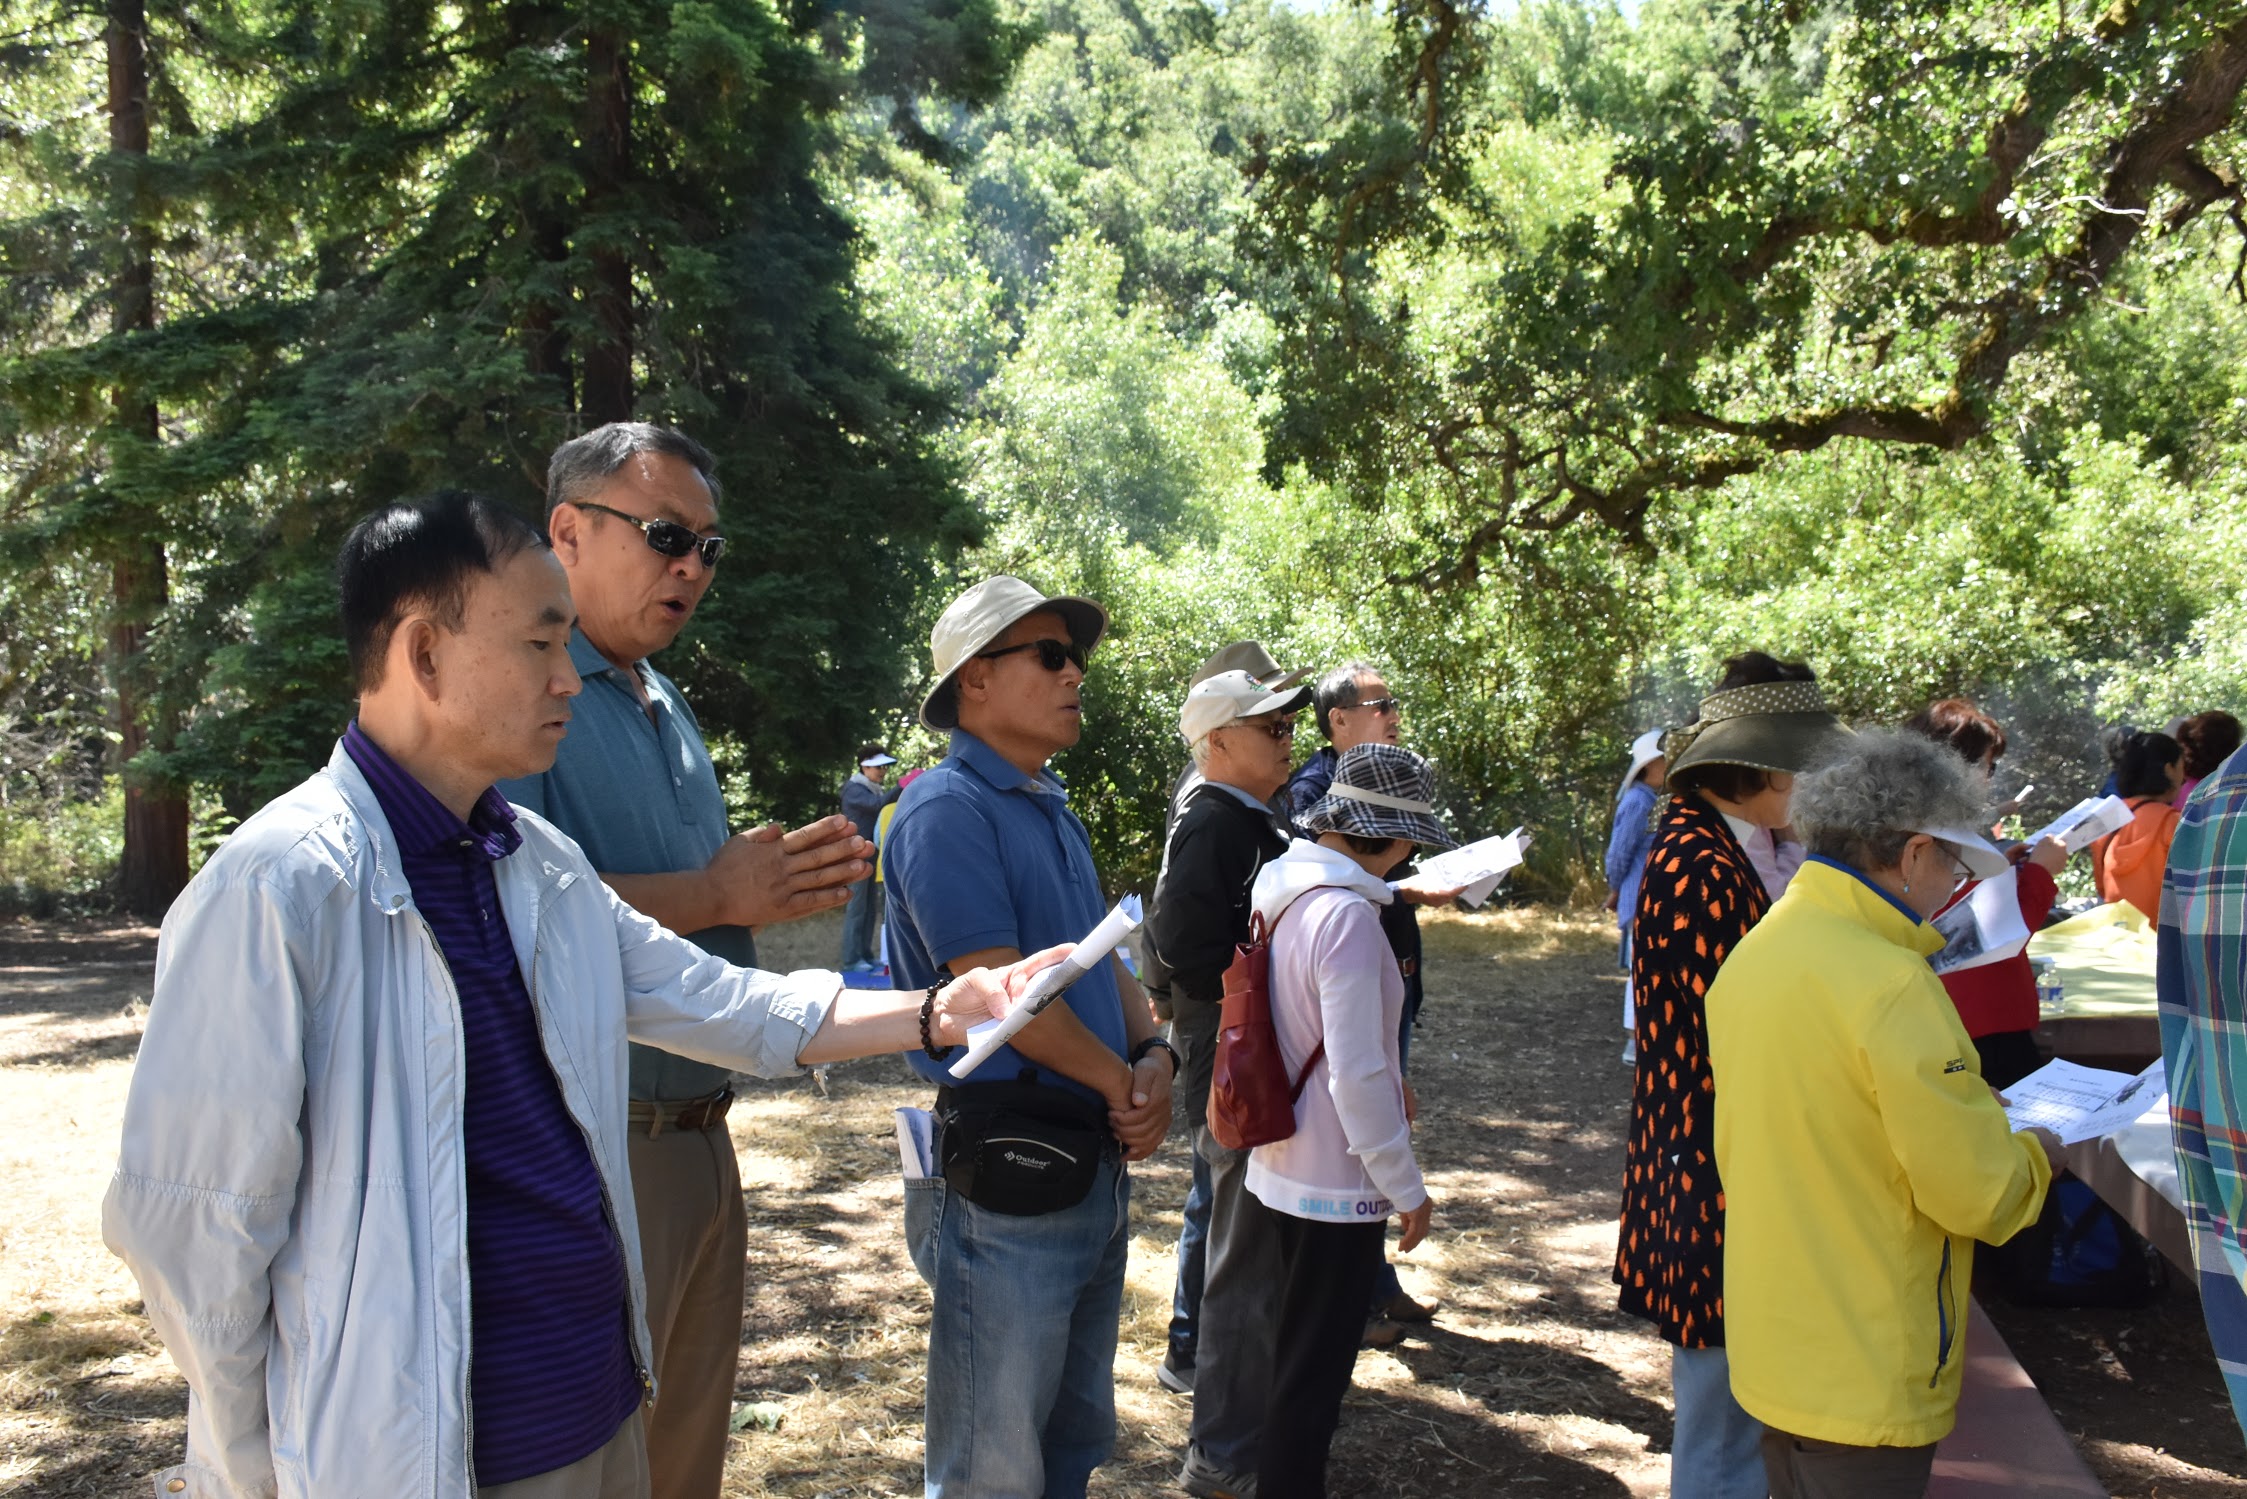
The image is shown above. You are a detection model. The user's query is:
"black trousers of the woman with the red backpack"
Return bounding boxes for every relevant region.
[1245,1198,1389,1499]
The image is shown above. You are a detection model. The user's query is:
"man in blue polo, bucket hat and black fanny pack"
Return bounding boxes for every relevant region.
[883,578,1177,1499]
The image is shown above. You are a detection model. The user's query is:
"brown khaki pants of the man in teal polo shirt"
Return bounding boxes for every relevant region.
[631,1124,748,1499]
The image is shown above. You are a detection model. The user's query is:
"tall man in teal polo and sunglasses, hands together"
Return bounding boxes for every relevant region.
[499,423,872,1499]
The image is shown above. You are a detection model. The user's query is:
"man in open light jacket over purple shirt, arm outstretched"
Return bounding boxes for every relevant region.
[103,494,1054,1499]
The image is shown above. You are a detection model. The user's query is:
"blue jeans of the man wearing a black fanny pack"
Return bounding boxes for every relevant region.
[906,1160,1130,1499]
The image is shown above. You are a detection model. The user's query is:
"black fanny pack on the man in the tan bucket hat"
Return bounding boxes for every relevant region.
[937,1083,1121,1218]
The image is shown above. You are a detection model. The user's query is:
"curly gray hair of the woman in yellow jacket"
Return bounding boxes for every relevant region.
[1793,728,1989,870]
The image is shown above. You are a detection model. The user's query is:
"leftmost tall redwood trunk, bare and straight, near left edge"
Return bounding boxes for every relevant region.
[106,0,187,917]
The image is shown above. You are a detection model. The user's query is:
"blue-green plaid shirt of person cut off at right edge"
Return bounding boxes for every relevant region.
[2159,753,2247,1432]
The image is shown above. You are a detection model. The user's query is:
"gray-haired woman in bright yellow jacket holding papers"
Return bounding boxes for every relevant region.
[1708,730,2060,1499]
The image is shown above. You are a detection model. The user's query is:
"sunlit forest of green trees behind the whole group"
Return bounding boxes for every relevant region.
[0,0,2247,912]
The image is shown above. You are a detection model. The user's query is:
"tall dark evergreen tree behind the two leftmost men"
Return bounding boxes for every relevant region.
[0,0,1018,871]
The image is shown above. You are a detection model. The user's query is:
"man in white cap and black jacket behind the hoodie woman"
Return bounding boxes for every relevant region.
[1148,670,1310,1420]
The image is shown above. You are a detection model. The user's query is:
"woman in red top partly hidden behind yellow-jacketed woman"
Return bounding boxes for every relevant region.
[1905,697,2067,1088]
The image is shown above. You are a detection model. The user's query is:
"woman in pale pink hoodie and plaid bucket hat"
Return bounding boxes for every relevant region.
[1247,744,1452,1499]
